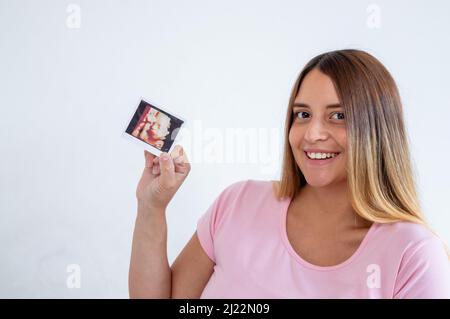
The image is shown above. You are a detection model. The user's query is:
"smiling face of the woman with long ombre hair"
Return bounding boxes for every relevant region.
[289,69,347,187]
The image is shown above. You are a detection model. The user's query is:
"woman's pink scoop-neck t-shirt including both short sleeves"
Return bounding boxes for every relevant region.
[197,180,450,298]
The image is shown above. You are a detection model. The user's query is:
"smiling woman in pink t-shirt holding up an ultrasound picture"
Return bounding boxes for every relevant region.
[129,50,450,298]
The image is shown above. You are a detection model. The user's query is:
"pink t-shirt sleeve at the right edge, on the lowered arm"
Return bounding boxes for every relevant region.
[394,237,450,299]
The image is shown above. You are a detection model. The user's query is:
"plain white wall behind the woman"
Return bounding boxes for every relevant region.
[0,0,450,298]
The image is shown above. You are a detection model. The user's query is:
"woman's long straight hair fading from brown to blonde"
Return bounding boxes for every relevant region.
[276,49,426,225]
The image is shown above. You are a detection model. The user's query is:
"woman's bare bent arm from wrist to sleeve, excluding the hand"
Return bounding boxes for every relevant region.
[129,205,214,298]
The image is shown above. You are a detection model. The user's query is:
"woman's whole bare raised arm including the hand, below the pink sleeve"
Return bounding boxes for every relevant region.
[128,146,214,298]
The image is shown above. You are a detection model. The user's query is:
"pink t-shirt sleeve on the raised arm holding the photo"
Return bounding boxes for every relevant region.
[197,182,246,263]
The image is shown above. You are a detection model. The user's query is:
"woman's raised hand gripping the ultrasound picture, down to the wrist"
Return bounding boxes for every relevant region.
[136,145,191,211]
